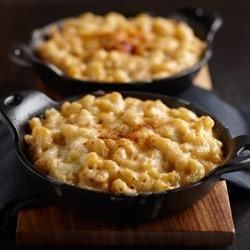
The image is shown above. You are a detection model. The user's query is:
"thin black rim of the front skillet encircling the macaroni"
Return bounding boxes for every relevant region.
[15,90,230,199]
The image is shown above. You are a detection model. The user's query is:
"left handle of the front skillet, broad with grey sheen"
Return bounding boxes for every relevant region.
[0,90,56,138]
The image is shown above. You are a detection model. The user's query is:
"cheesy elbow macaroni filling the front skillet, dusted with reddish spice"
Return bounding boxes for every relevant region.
[25,92,223,194]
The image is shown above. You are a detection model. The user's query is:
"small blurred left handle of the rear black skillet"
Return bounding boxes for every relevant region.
[8,43,36,67]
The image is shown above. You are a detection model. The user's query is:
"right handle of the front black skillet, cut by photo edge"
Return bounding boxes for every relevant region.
[211,135,250,176]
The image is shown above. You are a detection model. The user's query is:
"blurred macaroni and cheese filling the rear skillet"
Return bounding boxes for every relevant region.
[37,12,206,83]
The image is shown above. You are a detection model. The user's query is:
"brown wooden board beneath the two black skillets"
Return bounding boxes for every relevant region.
[16,68,235,246]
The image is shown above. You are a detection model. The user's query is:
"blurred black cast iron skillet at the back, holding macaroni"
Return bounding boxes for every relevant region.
[9,8,222,95]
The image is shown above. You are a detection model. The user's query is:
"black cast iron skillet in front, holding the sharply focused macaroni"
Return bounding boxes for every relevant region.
[0,90,250,219]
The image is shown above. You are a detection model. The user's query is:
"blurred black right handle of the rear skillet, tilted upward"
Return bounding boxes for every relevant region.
[174,8,223,43]
